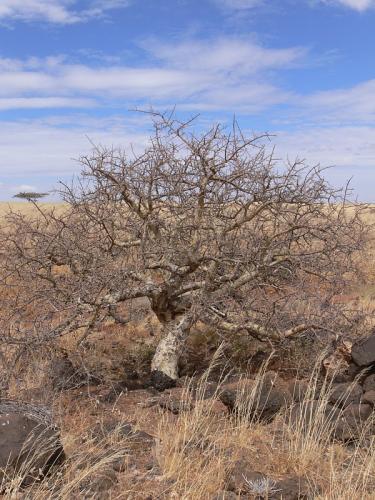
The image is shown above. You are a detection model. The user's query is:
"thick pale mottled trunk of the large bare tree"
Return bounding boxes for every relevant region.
[151,315,192,391]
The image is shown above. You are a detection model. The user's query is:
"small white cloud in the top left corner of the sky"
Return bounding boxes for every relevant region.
[0,0,129,24]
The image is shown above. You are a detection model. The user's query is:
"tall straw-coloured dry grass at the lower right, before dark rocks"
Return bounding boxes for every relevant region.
[153,358,375,500]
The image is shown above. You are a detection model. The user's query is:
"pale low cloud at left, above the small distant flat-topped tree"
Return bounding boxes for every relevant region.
[0,116,148,185]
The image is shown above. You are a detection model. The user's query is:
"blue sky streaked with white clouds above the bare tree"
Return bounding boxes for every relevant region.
[0,0,375,201]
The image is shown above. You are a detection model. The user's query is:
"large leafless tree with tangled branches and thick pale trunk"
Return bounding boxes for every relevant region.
[2,115,366,389]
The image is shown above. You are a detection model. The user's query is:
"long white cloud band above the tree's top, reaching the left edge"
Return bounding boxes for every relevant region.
[0,38,305,111]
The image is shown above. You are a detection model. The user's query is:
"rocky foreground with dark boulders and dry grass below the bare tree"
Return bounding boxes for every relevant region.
[0,334,375,500]
